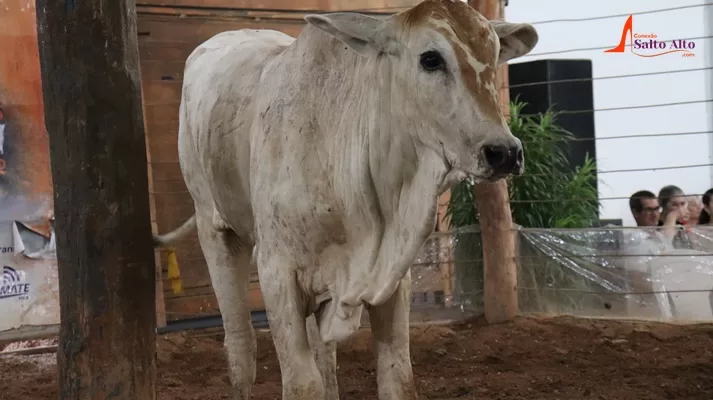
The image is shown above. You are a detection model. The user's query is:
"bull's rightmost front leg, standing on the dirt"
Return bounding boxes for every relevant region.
[369,271,418,400]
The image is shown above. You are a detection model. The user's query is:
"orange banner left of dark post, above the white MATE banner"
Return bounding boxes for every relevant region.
[0,0,52,221]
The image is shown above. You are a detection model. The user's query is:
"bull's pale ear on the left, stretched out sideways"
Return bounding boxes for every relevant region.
[305,12,392,56]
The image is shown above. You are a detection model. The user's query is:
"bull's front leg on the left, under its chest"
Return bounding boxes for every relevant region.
[257,252,331,400]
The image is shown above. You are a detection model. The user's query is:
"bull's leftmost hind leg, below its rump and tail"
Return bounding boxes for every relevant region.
[196,214,257,400]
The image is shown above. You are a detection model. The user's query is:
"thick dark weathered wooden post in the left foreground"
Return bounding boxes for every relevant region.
[37,0,156,400]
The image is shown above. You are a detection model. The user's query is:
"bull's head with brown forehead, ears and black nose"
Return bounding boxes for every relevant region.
[305,0,538,182]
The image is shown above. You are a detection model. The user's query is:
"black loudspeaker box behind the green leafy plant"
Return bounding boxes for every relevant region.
[508,60,596,192]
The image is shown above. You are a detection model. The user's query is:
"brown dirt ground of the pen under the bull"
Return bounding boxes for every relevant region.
[0,317,713,400]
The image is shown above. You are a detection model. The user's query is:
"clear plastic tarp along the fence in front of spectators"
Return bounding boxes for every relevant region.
[412,226,713,322]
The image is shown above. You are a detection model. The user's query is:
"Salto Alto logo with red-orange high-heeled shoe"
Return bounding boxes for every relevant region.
[604,15,696,57]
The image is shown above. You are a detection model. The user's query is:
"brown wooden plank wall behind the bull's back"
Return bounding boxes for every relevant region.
[137,0,447,321]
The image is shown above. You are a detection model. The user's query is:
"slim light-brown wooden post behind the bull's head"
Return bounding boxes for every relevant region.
[469,0,518,323]
